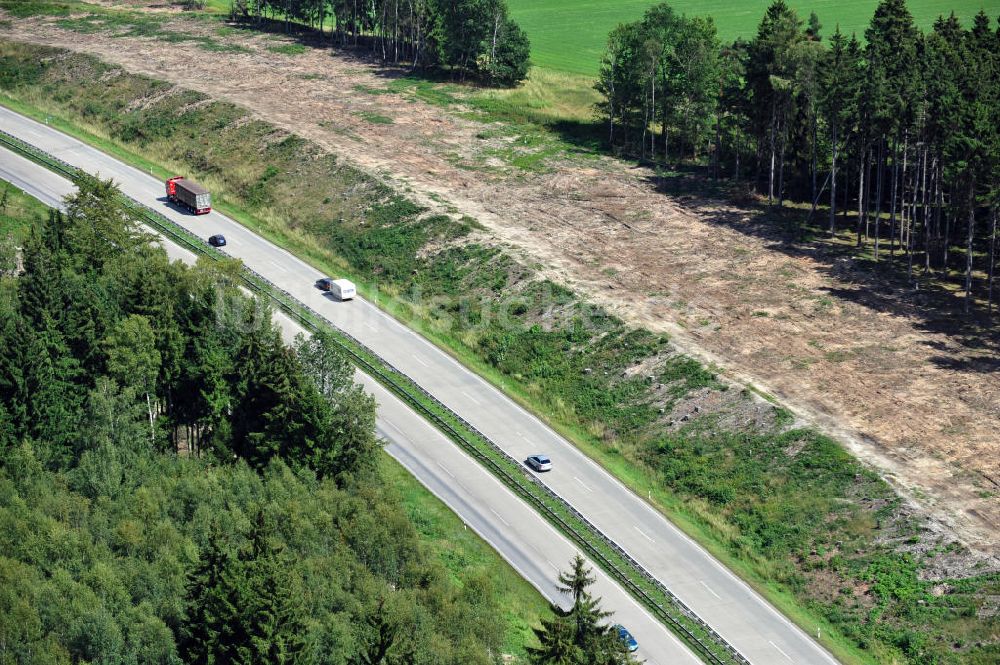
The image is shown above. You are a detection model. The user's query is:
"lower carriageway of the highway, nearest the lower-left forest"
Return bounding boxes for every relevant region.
[0,143,701,665]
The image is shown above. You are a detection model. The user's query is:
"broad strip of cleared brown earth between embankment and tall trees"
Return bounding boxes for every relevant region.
[0,14,1000,557]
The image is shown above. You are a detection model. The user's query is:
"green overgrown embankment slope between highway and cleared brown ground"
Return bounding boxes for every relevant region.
[0,33,998,662]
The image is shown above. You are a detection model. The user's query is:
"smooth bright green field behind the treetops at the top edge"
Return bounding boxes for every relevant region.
[507,0,1000,75]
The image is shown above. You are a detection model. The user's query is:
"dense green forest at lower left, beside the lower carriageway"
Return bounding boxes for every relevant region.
[0,180,516,665]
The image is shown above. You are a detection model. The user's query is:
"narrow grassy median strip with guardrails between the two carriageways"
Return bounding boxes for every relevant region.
[0,130,750,665]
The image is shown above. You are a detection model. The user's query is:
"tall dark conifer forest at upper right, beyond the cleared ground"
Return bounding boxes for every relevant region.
[596,0,1000,314]
